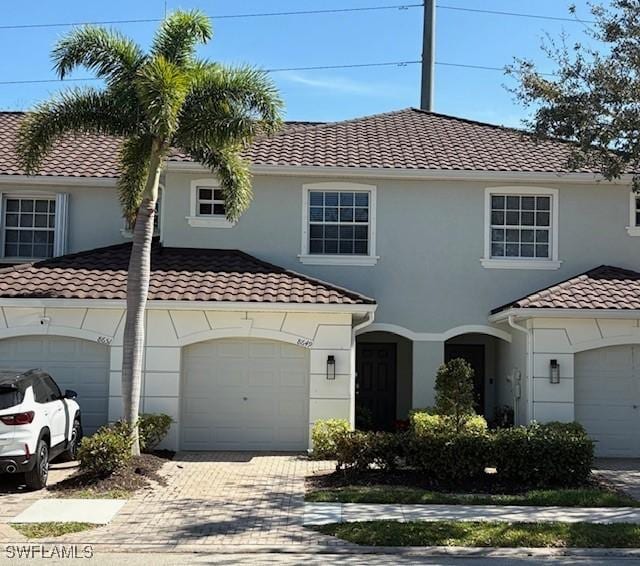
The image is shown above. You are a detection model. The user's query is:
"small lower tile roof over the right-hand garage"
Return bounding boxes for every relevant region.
[492,265,640,313]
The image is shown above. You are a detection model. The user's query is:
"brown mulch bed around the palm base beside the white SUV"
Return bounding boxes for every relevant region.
[47,450,175,497]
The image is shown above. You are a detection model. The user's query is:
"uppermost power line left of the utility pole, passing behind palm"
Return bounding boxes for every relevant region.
[0,3,423,30]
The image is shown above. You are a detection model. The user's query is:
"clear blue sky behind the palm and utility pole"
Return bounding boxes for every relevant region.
[0,0,608,125]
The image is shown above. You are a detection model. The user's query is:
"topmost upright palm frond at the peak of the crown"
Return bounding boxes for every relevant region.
[151,10,213,66]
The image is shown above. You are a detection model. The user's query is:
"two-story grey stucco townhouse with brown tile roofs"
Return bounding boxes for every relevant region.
[0,109,640,456]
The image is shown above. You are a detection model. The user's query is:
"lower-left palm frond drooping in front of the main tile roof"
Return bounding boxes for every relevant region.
[17,88,135,174]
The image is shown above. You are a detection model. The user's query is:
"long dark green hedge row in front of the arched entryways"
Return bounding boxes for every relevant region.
[320,418,593,487]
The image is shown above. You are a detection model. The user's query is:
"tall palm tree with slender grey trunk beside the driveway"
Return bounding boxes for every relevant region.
[17,11,282,454]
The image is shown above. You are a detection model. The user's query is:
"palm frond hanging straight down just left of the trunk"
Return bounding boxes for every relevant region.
[118,136,153,224]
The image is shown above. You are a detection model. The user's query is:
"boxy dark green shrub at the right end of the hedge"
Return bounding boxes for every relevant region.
[492,423,594,486]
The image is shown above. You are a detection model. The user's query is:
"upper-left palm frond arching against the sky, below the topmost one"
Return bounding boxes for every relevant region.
[52,26,145,80]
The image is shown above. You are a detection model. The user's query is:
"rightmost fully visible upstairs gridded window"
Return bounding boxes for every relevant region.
[491,194,552,259]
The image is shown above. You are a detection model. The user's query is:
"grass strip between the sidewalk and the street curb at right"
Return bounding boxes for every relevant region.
[314,521,640,548]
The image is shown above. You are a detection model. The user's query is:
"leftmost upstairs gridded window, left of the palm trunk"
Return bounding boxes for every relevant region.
[3,198,56,259]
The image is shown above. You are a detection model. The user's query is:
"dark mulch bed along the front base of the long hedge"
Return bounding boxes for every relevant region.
[305,470,610,495]
